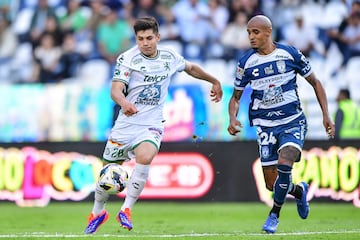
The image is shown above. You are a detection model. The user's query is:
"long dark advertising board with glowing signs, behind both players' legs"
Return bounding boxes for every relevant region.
[0,141,360,207]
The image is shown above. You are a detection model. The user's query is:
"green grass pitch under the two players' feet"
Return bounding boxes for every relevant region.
[0,200,360,240]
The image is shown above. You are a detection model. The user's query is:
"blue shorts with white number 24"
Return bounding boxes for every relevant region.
[257,117,307,166]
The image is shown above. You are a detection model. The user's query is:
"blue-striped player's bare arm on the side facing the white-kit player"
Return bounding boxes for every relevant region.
[228,88,244,136]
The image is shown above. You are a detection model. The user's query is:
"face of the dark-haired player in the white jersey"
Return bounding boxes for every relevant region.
[136,29,160,57]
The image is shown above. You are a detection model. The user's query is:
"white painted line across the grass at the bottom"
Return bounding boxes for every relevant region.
[0,229,360,238]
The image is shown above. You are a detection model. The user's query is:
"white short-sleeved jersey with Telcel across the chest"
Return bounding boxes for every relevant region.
[113,46,185,125]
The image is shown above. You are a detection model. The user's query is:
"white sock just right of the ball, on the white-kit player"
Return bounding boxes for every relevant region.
[121,163,150,210]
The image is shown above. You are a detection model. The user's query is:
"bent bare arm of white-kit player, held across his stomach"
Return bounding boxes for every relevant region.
[111,81,138,116]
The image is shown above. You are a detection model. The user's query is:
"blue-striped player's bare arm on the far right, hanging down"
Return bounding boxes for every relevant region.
[305,72,335,138]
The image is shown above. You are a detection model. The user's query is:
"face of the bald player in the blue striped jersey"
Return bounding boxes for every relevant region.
[247,24,271,49]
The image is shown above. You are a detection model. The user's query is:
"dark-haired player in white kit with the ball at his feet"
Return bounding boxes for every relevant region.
[85,17,222,234]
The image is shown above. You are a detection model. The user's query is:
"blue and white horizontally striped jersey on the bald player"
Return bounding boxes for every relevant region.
[234,43,312,127]
